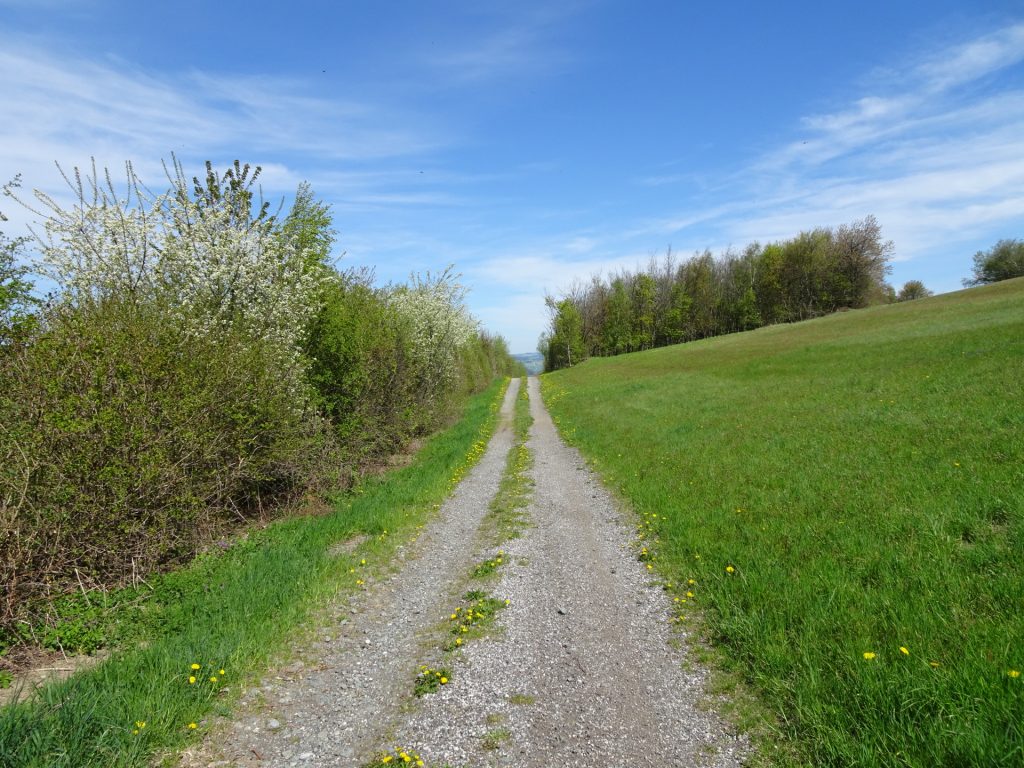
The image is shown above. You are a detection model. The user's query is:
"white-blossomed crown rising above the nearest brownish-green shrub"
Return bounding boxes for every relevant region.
[36,164,324,356]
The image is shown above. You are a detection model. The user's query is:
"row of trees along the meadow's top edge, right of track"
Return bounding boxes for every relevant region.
[539,216,895,371]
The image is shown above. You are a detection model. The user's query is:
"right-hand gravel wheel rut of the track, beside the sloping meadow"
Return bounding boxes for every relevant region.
[387,378,748,768]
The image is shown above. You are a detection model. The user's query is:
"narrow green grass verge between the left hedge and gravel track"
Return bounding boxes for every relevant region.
[0,382,504,768]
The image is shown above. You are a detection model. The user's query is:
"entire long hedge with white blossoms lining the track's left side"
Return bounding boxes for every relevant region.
[0,163,518,638]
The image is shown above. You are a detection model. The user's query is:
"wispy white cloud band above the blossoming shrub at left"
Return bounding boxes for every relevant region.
[0,44,442,198]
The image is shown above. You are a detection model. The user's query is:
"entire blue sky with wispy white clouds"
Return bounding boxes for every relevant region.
[0,0,1024,351]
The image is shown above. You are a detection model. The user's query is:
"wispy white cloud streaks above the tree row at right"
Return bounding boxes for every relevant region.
[636,25,1024,268]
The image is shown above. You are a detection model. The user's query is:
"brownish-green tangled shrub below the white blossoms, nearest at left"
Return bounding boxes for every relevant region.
[0,300,329,622]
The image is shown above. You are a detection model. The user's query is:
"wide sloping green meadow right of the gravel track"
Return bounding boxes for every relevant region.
[543,280,1024,766]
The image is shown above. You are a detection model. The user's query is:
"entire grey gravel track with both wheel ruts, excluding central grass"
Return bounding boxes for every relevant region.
[188,378,748,768]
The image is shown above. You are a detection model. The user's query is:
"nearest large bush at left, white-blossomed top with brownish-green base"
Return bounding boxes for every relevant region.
[0,165,335,630]
